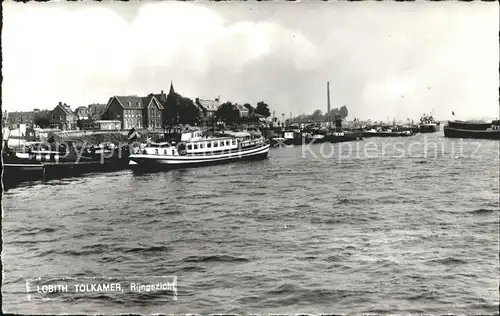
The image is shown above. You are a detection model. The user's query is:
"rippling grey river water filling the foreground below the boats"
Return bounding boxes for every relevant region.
[2,133,500,314]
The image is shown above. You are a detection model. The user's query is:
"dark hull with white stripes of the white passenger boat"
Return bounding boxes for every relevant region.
[129,144,270,170]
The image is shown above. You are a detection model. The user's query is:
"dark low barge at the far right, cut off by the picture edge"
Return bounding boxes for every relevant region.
[444,120,500,140]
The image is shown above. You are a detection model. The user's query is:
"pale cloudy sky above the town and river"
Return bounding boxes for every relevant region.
[2,1,500,121]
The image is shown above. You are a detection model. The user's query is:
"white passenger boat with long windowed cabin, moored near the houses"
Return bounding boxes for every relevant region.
[129,129,269,168]
